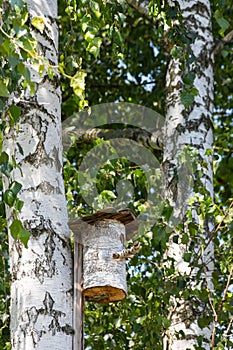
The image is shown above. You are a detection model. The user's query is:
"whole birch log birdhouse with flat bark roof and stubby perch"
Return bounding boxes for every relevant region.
[70,208,140,302]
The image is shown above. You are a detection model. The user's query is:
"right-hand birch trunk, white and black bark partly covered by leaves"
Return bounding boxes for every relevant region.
[163,0,213,350]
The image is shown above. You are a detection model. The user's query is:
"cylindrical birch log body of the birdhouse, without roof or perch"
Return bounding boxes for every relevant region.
[82,220,127,302]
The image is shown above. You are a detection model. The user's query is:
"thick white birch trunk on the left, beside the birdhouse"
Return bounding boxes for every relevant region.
[5,0,73,350]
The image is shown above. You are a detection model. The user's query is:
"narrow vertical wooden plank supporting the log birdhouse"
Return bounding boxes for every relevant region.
[73,238,84,350]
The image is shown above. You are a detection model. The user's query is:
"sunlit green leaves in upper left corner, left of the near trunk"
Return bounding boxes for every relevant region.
[0,0,37,105]
